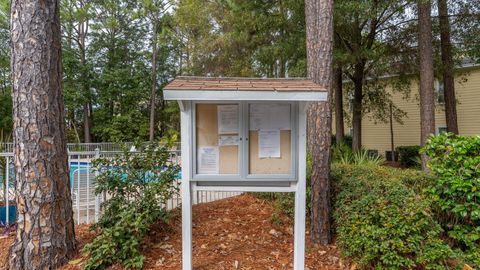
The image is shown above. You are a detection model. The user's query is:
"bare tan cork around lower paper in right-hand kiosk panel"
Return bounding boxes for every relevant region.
[249,130,292,174]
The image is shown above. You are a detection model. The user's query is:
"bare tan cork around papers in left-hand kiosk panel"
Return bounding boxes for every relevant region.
[195,104,239,174]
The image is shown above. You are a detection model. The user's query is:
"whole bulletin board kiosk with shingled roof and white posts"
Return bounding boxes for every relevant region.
[164,77,327,270]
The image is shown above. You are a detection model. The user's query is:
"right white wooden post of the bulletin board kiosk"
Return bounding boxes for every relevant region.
[293,102,307,270]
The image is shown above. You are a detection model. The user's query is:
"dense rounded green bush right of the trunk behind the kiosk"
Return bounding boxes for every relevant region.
[332,164,455,269]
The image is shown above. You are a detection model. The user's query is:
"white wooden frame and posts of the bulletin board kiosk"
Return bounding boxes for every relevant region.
[164,77,327,270]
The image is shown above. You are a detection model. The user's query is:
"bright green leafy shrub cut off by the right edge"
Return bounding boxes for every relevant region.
[422,133,480,265]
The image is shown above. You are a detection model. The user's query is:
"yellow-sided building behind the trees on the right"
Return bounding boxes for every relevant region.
[333,66,480,156]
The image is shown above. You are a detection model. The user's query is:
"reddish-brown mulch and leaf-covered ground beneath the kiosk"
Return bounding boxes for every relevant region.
[0,194,348,270]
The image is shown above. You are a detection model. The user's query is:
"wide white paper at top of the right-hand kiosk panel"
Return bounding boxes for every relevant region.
[250,103,291,130]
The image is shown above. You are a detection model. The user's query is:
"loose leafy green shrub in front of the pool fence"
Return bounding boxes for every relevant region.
[84,144,179,270]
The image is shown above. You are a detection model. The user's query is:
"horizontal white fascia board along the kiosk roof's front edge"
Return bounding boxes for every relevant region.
[163,90,328,101]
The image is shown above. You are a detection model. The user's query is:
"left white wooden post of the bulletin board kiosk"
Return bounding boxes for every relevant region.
[179,101,192,270]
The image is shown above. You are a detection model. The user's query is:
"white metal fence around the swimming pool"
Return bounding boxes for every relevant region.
[0,143,241,224]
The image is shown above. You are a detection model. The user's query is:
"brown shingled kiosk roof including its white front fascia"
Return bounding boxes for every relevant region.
[163,77,327,101]
